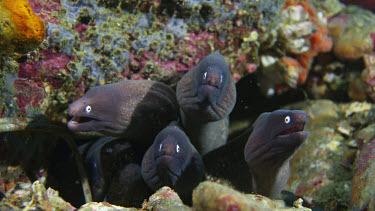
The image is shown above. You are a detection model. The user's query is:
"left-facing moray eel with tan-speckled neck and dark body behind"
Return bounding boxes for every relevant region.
[68,80,178,146]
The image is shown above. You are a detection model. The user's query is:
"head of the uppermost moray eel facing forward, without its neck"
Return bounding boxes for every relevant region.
[177,51,237,121]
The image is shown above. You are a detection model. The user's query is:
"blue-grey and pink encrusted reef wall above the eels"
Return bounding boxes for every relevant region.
[0,0,348,121]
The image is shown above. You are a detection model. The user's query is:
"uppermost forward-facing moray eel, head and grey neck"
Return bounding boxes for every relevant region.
[176,51,236,155]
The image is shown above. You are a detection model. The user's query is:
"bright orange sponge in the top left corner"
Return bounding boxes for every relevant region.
[0,0,45,54]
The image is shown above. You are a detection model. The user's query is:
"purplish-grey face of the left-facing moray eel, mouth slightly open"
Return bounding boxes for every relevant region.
[68,85,121,134]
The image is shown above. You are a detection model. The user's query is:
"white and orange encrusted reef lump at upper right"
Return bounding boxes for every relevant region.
[259,0,332,96]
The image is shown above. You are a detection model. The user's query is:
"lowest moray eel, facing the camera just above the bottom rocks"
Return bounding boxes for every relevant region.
[141,122,205,203]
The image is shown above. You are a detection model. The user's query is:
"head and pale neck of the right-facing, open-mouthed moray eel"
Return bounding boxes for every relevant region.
[244,110,309,198]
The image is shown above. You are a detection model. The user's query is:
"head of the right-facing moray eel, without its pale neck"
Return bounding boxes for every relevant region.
[245,110,309,167]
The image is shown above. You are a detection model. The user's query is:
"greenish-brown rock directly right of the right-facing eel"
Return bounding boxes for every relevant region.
[286,100,374,210]
